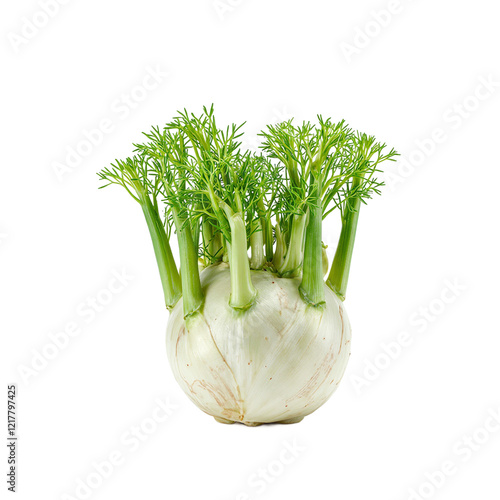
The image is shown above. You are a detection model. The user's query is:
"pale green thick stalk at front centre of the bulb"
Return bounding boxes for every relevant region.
[220,202,257,310]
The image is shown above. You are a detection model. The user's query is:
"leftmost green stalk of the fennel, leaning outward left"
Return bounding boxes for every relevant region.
[140,195,182,309]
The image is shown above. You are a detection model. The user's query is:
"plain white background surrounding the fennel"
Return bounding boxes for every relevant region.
[0,0,500,500]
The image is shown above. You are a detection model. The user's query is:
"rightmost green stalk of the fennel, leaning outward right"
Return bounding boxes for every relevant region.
[326,198,361,300]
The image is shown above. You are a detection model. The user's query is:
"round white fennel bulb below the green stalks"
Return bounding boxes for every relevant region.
[167,264,351,425]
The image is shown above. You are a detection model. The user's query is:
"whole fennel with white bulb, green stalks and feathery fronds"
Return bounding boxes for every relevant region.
[99,106,397,425]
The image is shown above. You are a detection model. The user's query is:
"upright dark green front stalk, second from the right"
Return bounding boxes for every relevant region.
[299,174,325,307]
